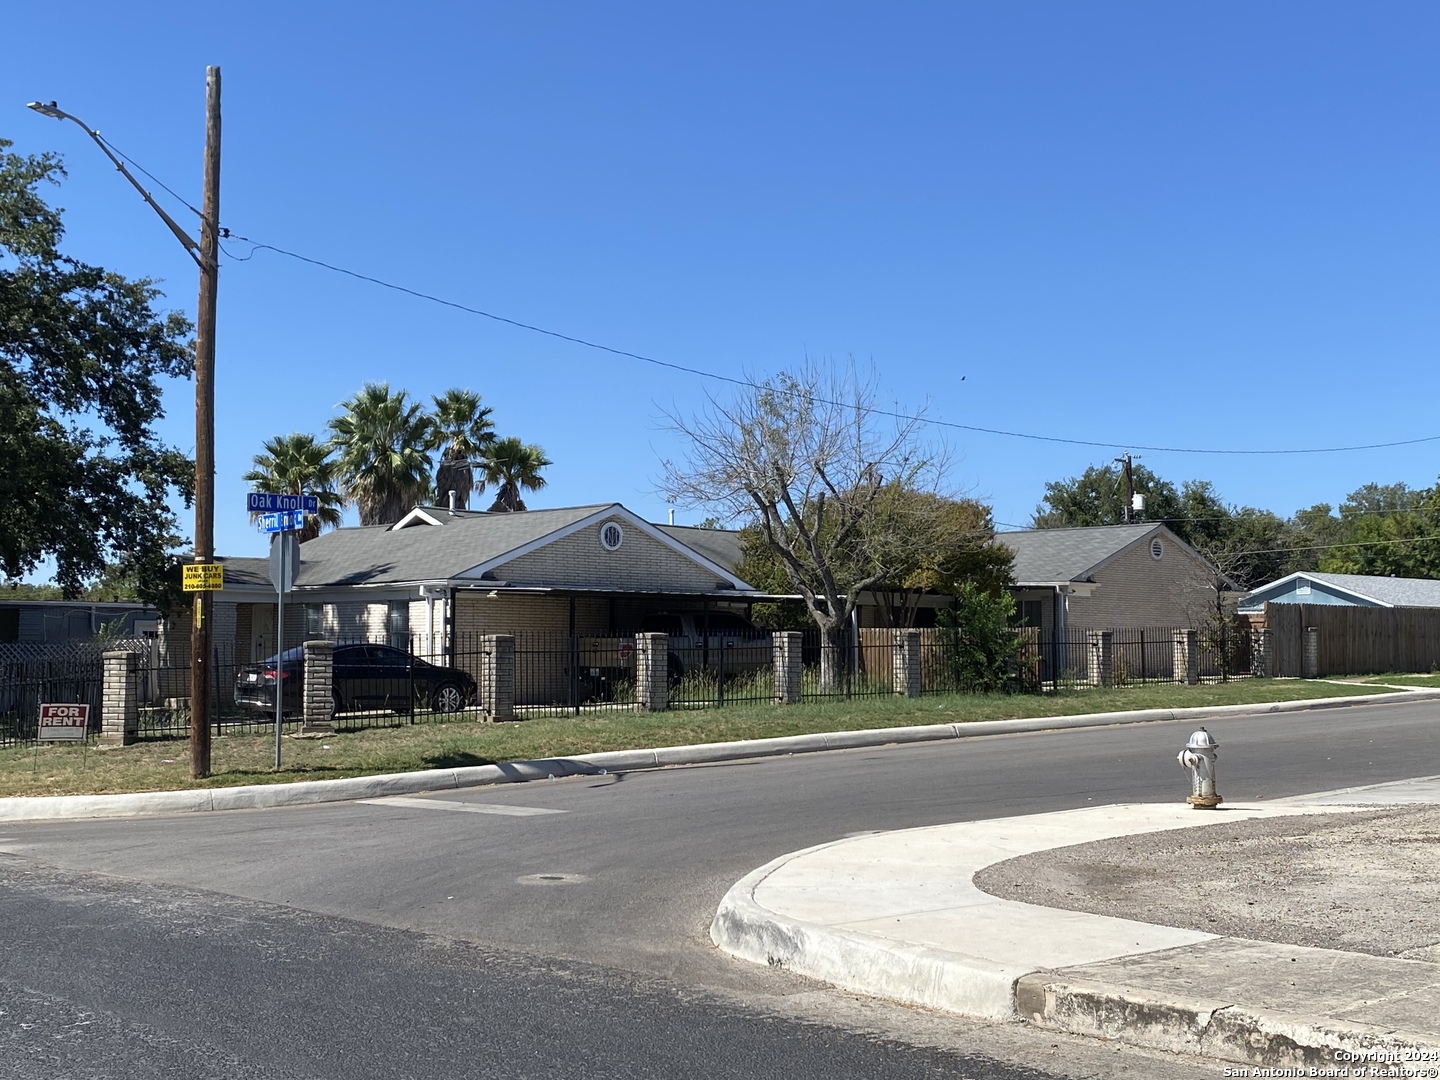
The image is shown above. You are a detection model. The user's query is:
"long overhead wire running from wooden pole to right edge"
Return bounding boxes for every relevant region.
[223,230,1440,456]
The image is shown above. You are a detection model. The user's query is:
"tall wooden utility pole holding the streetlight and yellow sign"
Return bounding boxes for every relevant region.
[190,66,220,779]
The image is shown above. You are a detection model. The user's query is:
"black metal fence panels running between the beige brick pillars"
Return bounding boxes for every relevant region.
[0,625,1251,746]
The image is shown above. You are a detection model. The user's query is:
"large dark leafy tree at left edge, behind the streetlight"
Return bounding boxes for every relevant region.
[0,140,194,608]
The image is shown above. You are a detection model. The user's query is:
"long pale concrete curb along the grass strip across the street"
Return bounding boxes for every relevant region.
[0,690,1440,821]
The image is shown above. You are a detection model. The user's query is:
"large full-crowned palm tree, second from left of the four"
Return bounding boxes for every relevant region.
[330,383,435,526]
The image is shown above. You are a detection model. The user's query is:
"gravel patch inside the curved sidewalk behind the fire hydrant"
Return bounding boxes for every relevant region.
[975,805,1440,962]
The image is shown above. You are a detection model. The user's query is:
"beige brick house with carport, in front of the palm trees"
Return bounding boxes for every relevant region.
[160,503,773,685]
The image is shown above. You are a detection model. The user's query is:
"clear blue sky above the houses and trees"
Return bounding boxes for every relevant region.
[0,0,1440,567]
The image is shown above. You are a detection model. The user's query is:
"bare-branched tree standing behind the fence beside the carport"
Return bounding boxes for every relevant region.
[664,361,942,688]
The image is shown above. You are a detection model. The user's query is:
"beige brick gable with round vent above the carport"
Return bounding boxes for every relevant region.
[495,520,721,592]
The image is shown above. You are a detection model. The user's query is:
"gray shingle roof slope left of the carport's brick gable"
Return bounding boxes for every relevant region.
[289,503,618,588]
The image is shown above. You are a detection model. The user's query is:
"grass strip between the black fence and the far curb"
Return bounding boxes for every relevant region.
[0,680,1384,796]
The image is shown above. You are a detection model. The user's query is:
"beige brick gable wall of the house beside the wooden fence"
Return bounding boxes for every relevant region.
[1068,536,1214,629]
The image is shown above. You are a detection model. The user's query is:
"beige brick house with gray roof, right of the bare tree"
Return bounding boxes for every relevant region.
[995,524,1233,634]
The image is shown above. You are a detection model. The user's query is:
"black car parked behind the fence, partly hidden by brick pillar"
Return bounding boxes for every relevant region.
[235,642,475,714]
